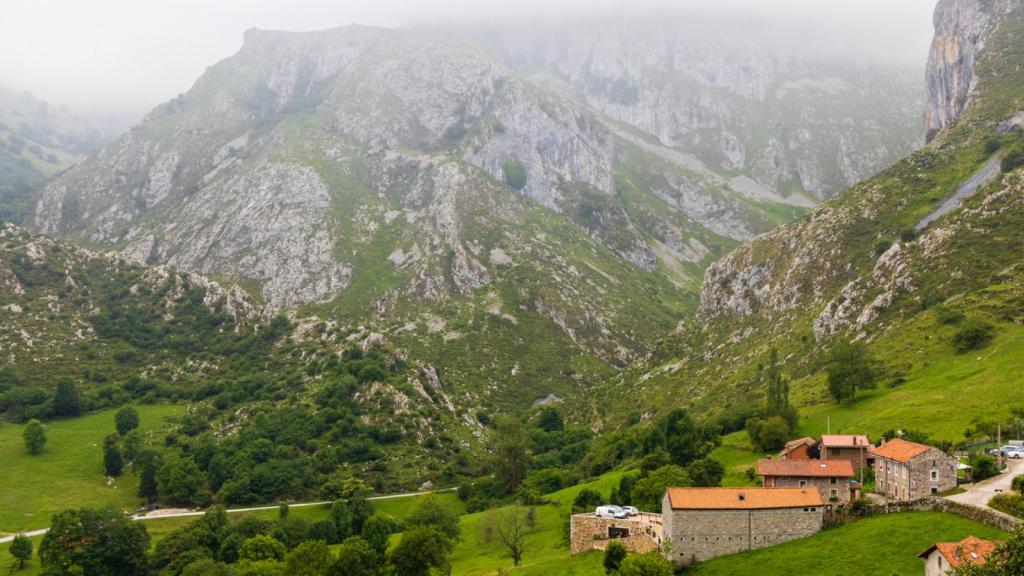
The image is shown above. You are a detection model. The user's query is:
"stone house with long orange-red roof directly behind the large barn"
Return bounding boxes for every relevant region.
[757,460,860,506]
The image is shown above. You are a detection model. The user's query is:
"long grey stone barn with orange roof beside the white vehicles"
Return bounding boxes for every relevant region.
[662,488,824,565]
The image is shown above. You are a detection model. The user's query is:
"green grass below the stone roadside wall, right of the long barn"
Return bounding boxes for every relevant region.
[688,512,1007,576]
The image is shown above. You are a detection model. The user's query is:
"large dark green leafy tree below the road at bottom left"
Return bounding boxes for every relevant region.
[39,508,150,576]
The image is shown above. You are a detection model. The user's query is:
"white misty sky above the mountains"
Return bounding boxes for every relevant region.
[0,0,935,125]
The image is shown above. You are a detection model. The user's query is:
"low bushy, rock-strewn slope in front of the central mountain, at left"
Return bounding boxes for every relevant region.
[0,219,482,487]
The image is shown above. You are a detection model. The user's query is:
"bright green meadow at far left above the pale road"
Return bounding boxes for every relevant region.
[0,405,184,533]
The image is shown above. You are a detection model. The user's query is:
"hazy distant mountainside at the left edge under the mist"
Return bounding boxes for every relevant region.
[0,86,110,222]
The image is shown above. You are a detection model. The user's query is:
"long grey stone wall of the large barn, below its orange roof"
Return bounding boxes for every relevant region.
[665,507,824,564]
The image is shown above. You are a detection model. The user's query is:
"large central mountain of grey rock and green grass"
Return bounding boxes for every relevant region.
[30,20,929,420]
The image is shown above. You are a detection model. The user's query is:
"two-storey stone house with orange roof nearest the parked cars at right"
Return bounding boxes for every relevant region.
[874,439,956,501]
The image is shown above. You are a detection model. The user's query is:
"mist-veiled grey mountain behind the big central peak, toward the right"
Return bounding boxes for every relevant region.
[457,14,923,201]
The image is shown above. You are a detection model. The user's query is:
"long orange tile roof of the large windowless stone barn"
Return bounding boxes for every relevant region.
[666,488,824,510]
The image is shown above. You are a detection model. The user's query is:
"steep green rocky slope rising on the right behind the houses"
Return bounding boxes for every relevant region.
[616,0,1024,440]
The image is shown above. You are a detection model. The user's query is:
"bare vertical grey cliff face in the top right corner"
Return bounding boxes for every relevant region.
[925,0,1012,137]
